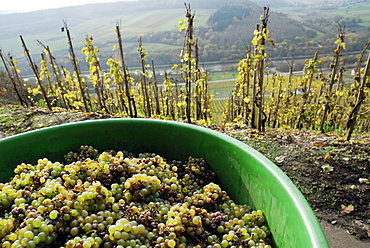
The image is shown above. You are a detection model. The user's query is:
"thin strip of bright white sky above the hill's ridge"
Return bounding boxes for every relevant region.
[0,0,134,12]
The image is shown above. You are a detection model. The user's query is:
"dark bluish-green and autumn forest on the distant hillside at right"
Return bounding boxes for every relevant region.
[129,4,370,68]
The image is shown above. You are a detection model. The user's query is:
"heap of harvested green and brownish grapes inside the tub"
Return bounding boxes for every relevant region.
[0,145,271,248]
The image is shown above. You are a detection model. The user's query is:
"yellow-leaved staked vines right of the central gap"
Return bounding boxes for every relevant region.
[225,16,370,140]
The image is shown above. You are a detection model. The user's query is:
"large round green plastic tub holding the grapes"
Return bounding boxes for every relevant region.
[0,119,329,248]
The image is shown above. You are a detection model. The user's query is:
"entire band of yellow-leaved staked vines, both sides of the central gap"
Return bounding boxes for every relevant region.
[0,4,370,140]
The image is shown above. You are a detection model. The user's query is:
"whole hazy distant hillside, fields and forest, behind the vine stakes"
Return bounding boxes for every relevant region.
[0,0,370,75]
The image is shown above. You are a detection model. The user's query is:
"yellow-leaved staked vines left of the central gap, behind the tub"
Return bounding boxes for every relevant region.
[0,5,212,126]
